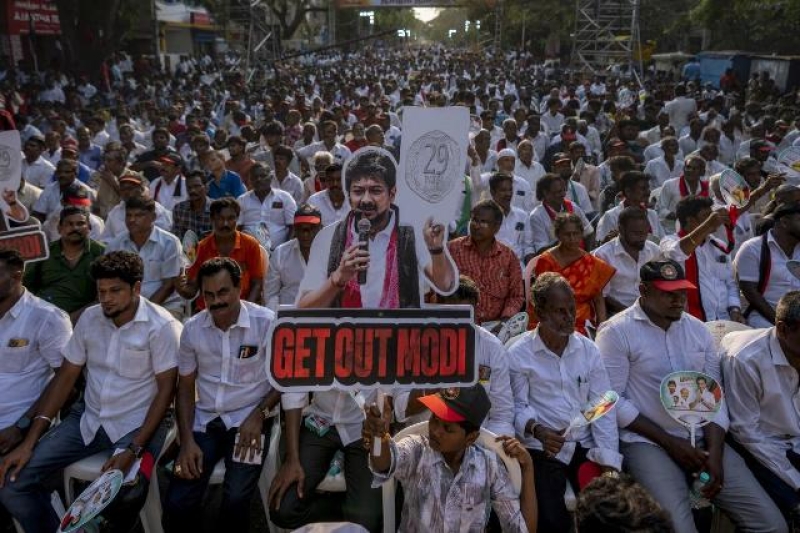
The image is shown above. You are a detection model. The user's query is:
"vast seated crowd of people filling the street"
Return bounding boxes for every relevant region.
[0,47,800,533]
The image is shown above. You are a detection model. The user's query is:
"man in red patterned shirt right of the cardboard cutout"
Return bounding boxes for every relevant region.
[448,200,525,328]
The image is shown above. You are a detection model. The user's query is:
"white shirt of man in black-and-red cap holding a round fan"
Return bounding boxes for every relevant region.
[597,301,728,444]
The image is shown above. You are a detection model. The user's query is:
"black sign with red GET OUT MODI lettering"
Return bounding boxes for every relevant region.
[267,306,477,392]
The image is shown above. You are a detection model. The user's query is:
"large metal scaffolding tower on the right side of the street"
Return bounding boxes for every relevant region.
[572,0,641,72]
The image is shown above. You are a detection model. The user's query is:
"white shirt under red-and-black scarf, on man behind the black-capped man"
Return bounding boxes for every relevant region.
[661,235,742,321]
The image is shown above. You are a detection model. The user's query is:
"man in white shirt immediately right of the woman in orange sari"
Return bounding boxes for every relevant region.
[592,206,661,314]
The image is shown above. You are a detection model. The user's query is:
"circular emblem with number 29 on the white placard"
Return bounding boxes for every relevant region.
[405,130,463,204]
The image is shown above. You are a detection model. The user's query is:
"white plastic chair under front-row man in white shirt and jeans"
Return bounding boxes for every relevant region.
[64,424,178,533]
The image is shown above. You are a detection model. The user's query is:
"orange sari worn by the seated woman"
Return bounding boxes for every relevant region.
[525,251,617,335]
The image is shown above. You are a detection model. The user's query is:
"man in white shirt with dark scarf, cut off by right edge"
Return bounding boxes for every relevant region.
[734,203,800,328]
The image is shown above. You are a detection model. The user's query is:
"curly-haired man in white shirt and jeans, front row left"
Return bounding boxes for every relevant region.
[0,252,181,533]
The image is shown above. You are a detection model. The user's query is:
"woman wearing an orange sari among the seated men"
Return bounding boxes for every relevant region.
[525,213,616,335]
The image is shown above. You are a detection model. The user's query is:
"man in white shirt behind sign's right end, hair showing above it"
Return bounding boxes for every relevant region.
[394,275,514,437]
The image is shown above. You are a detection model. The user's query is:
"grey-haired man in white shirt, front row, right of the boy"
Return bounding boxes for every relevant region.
[508,272,622,531]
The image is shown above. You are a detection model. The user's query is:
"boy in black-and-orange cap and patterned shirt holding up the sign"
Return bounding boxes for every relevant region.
[363,385,537,533]
